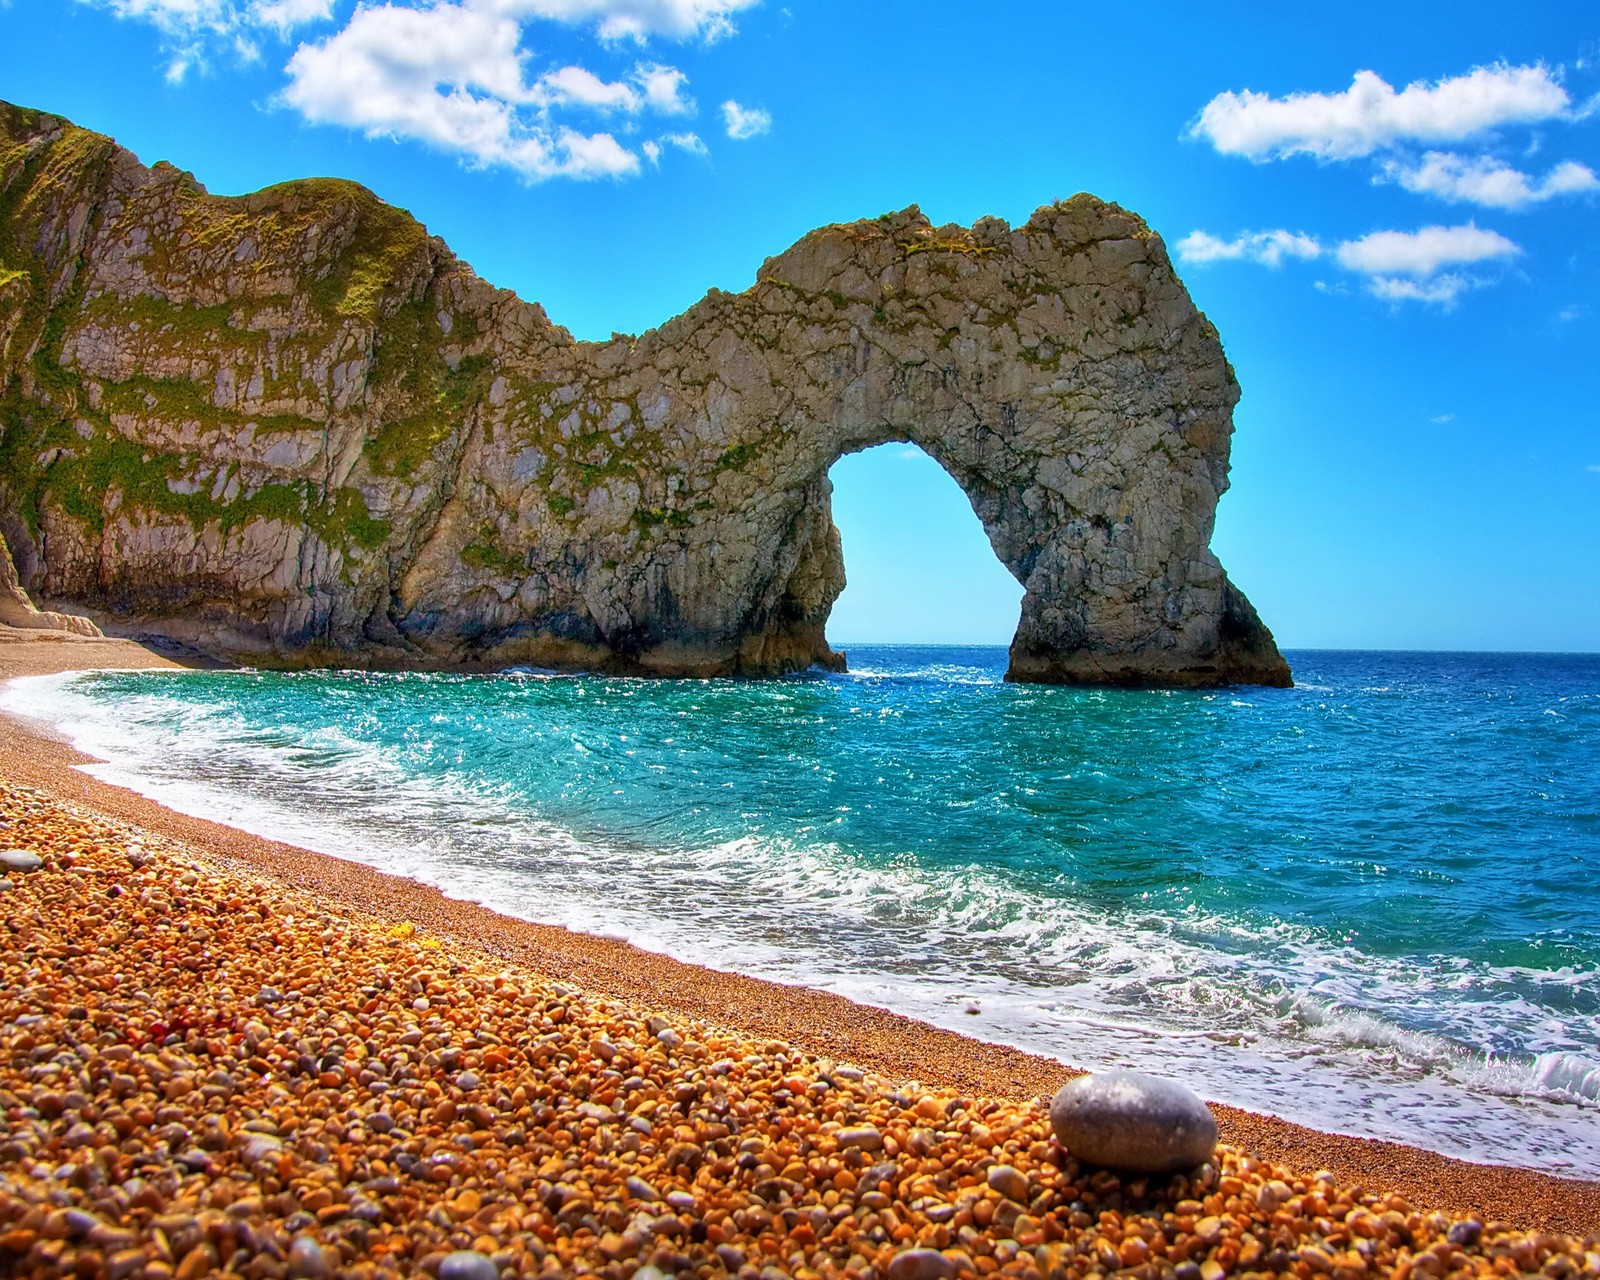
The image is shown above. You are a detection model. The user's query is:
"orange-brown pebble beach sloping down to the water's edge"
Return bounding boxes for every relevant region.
[0,640,1600,1280]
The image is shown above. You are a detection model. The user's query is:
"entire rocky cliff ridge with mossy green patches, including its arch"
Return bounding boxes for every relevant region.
[0,106,1288,685]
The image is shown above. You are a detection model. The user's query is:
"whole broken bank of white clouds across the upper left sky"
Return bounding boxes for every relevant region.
[78,0,771,182]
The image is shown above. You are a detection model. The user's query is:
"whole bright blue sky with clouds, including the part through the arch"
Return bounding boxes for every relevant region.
[0,0,1600,651]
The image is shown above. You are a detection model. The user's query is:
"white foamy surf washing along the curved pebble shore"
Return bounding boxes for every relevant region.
[0,674,1600,1176]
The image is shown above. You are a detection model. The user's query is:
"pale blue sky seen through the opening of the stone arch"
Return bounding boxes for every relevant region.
[827,443,1022,648]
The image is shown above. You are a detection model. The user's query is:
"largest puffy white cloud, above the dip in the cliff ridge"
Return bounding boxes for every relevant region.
[283,3,638,181]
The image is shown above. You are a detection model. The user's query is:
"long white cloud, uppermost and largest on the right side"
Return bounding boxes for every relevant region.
[1189,62,1573,160]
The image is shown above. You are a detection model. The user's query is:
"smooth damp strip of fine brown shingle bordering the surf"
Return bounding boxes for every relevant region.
[0,629,1600,1235]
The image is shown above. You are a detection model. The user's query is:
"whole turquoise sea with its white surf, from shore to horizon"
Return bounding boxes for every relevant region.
[0,648,1600,1176]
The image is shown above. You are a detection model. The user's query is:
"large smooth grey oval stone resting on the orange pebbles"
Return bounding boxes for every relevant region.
[1050,1070,1218,1173]
